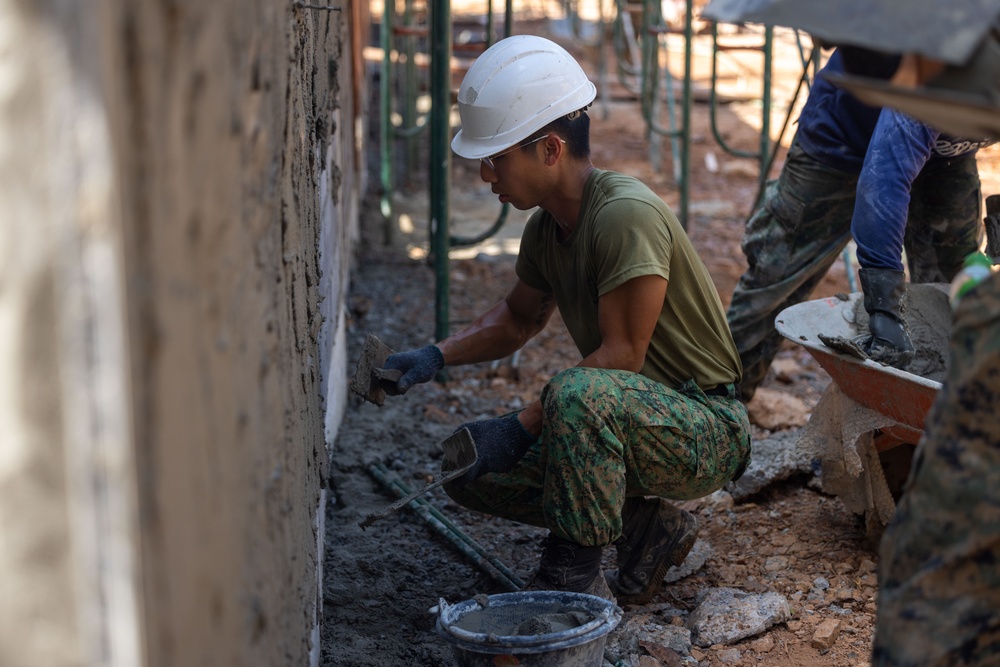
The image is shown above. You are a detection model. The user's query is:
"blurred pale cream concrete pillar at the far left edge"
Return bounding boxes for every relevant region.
[0,0,141,667]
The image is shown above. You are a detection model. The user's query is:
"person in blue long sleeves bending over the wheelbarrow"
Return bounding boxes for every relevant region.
[726,47,993,401]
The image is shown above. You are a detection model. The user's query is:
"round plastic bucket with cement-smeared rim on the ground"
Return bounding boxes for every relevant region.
[435,591,622,667]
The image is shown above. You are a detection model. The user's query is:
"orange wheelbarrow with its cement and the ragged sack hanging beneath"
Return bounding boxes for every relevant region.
[775,284,951,544]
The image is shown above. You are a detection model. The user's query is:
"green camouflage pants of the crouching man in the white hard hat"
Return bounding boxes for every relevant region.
[445,368,750,546]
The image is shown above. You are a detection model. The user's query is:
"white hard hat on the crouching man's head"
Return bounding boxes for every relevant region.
[451,35,597,159]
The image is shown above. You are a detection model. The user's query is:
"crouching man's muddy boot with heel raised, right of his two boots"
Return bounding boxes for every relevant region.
[605,498,698,604]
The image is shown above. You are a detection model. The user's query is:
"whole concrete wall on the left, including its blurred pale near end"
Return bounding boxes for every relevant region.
[0,0,364,667]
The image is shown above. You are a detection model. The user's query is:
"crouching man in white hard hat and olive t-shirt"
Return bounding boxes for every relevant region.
[385,35,750,604]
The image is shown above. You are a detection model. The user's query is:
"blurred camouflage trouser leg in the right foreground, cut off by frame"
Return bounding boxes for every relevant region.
[872,274,1000,667]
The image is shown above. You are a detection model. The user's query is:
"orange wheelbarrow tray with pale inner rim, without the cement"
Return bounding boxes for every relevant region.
[775,293,941,450]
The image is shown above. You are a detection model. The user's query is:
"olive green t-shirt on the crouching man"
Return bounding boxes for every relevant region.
[517,169,743,389]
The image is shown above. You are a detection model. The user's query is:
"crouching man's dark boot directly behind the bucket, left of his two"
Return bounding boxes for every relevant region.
[524,533,615,602]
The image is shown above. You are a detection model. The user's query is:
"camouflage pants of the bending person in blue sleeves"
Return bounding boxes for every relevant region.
[726,142,983,399]
